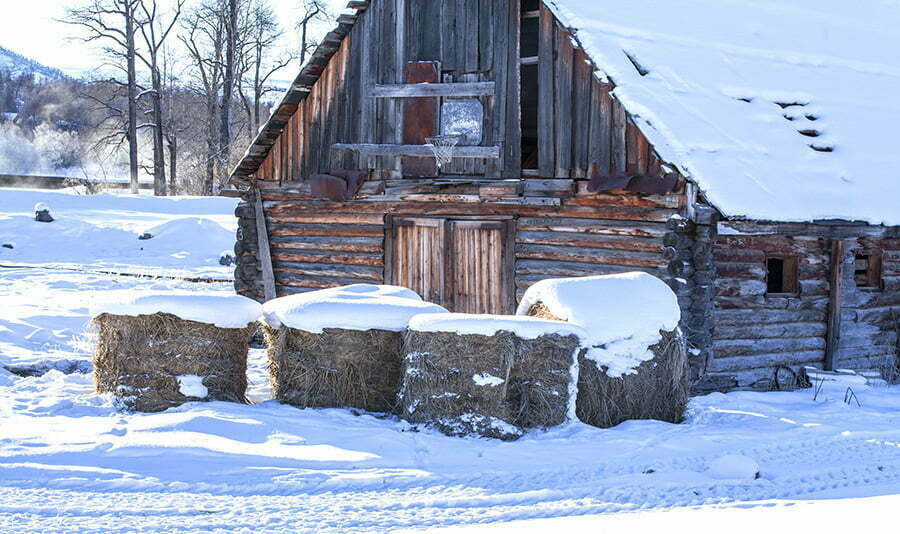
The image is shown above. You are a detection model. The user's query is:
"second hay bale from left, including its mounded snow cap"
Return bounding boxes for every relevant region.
[263,284,447,412]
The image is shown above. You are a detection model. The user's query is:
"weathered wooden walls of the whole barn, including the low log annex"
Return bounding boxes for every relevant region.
[232,0,900,391]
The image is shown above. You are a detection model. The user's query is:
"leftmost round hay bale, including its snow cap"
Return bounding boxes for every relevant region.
[91,293,262,412]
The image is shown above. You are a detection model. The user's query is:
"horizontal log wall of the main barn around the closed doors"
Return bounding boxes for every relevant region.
[235,190,692,320]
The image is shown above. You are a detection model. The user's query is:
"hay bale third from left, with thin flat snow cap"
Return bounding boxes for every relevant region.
[400,314,584,440]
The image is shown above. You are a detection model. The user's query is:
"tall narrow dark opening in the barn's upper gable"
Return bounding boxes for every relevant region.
[520,0,541,171]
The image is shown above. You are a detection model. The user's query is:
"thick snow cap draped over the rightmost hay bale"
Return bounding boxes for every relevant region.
[517,272,681,377]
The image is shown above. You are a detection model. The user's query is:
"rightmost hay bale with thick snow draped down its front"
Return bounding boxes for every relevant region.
[519,273,688,428]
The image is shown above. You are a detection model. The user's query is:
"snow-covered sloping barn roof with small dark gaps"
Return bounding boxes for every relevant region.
[547,0,900,225]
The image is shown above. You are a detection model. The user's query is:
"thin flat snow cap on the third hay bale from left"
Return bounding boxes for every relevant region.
[409,313,588,340]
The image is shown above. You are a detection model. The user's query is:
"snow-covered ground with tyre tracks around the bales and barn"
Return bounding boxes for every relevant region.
[0,189,900,533]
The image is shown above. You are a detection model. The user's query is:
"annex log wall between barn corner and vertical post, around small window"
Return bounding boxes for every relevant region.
[707,235,829,389]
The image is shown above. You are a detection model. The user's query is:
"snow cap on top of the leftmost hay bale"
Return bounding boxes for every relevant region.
[91,291,262,328]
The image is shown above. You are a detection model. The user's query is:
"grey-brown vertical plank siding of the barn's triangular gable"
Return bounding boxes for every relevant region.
[246,0,664,187]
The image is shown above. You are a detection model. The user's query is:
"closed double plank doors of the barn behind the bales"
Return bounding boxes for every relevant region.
[385,217,515,315]
